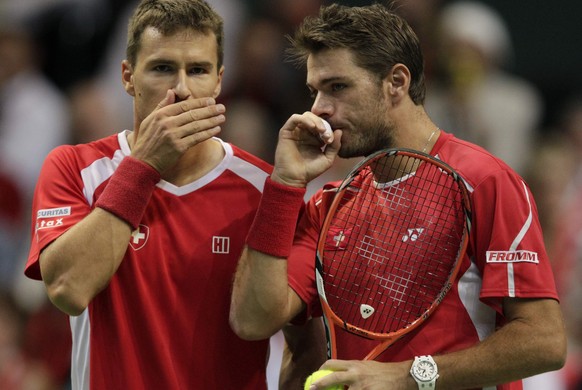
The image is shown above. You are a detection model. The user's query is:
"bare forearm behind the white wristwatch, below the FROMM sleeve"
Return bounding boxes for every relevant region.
[434,299,566,389]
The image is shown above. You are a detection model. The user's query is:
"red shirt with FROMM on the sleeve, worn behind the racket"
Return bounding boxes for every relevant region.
[288,132,558,390]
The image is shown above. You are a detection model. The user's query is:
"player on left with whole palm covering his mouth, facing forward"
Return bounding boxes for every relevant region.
[25,0,282,390]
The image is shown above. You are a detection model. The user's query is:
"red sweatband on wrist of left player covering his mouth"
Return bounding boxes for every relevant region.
[95,156,161,229]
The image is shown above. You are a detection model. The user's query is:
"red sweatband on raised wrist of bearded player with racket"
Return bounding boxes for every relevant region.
[247,177,306,258]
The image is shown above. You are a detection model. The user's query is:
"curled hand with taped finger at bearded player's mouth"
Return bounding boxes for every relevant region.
[272,112,341,187]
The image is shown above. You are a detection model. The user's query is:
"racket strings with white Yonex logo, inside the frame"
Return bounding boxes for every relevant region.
[324,157,463,333]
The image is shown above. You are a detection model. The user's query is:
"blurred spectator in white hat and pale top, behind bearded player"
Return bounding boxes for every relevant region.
[426,1,544,174]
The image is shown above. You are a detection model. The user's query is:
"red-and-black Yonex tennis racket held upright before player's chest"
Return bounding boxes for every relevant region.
[316,149,471,360]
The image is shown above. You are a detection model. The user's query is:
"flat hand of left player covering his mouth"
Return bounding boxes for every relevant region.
[132,90,226,173]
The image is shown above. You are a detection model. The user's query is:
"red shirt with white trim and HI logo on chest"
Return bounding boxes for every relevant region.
[25,132,272,390]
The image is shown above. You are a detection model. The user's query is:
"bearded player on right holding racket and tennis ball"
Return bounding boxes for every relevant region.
[230,5,566,390]
